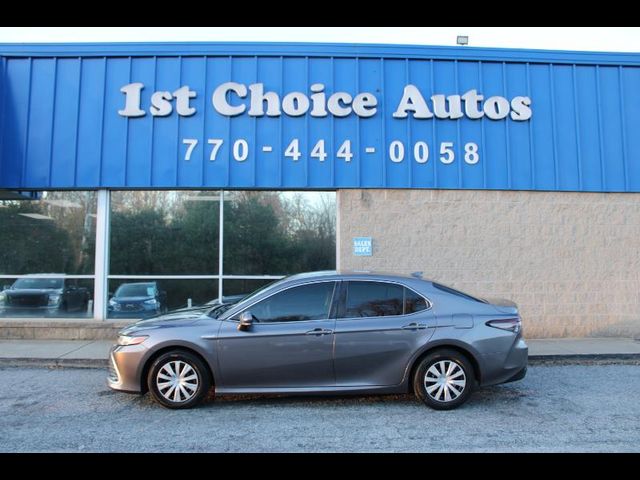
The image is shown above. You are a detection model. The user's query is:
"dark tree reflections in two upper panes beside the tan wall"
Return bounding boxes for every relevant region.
[110,192,335,275]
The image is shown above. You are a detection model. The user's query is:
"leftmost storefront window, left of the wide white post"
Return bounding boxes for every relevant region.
[0,192,96,318]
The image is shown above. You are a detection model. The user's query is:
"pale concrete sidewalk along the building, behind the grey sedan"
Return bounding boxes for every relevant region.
[0,338,640,368]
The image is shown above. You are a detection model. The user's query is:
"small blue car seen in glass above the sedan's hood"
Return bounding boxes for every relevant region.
[107,282,167,318]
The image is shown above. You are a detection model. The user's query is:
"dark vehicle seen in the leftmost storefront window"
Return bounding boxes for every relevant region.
[0,274,90,316]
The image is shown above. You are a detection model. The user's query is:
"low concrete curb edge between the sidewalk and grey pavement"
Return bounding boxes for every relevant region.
[0,353,640,368]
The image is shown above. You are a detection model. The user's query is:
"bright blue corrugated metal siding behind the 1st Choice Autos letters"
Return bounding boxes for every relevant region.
[0,44,640,192]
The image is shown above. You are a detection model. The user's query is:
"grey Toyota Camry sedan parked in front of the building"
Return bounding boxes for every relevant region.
[108,271,528,410]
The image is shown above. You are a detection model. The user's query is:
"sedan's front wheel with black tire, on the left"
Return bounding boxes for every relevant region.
[147,350,211,409]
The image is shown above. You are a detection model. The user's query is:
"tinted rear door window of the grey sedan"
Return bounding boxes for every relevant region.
[344,282,404,318]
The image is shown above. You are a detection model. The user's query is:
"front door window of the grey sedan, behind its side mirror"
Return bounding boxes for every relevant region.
[249,282,335,322]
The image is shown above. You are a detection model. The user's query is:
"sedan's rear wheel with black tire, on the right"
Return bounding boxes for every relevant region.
[413,348,476,410]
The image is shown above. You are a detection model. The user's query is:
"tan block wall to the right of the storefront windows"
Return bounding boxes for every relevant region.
[338,190,640,338]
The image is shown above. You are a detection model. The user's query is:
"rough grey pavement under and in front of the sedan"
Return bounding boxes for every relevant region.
[0,365,640,452]
